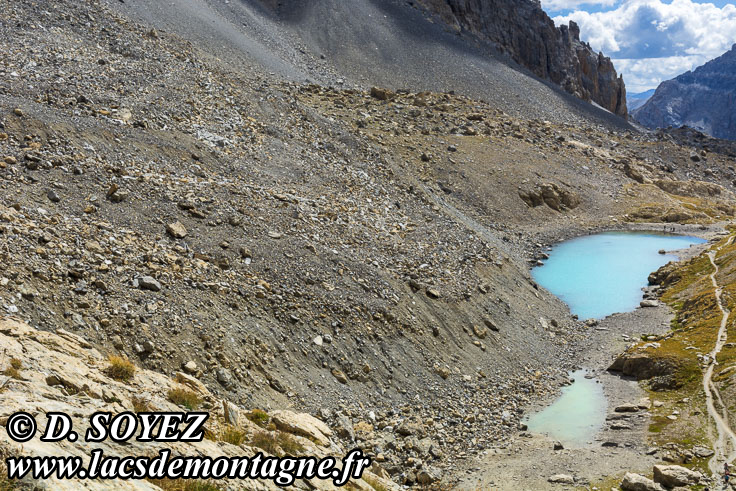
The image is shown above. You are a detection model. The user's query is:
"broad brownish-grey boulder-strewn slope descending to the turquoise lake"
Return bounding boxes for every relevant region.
[0,0,736,485]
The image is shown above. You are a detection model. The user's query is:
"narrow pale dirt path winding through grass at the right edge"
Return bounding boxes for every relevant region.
[703,237,736,475]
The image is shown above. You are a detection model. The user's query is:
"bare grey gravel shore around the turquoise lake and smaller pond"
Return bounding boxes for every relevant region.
[457,224,725,491]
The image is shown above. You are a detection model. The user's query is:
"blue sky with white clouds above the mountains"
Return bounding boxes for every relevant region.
[542,0,736,93]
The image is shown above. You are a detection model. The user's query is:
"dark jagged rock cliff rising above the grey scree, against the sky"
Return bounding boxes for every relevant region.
[420,0,627,118]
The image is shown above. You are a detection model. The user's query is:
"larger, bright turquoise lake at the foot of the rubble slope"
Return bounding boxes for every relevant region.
[532,232,705,319]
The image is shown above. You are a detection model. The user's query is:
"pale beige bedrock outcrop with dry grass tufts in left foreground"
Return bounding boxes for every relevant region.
[0,319,398,491]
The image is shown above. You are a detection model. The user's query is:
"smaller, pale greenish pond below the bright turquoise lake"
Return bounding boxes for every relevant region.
[527,370,606,447]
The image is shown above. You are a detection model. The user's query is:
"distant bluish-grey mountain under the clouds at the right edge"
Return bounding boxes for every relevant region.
[632,44,736,140]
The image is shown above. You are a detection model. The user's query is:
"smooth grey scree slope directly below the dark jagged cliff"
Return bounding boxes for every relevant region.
[110,0,628,129]
